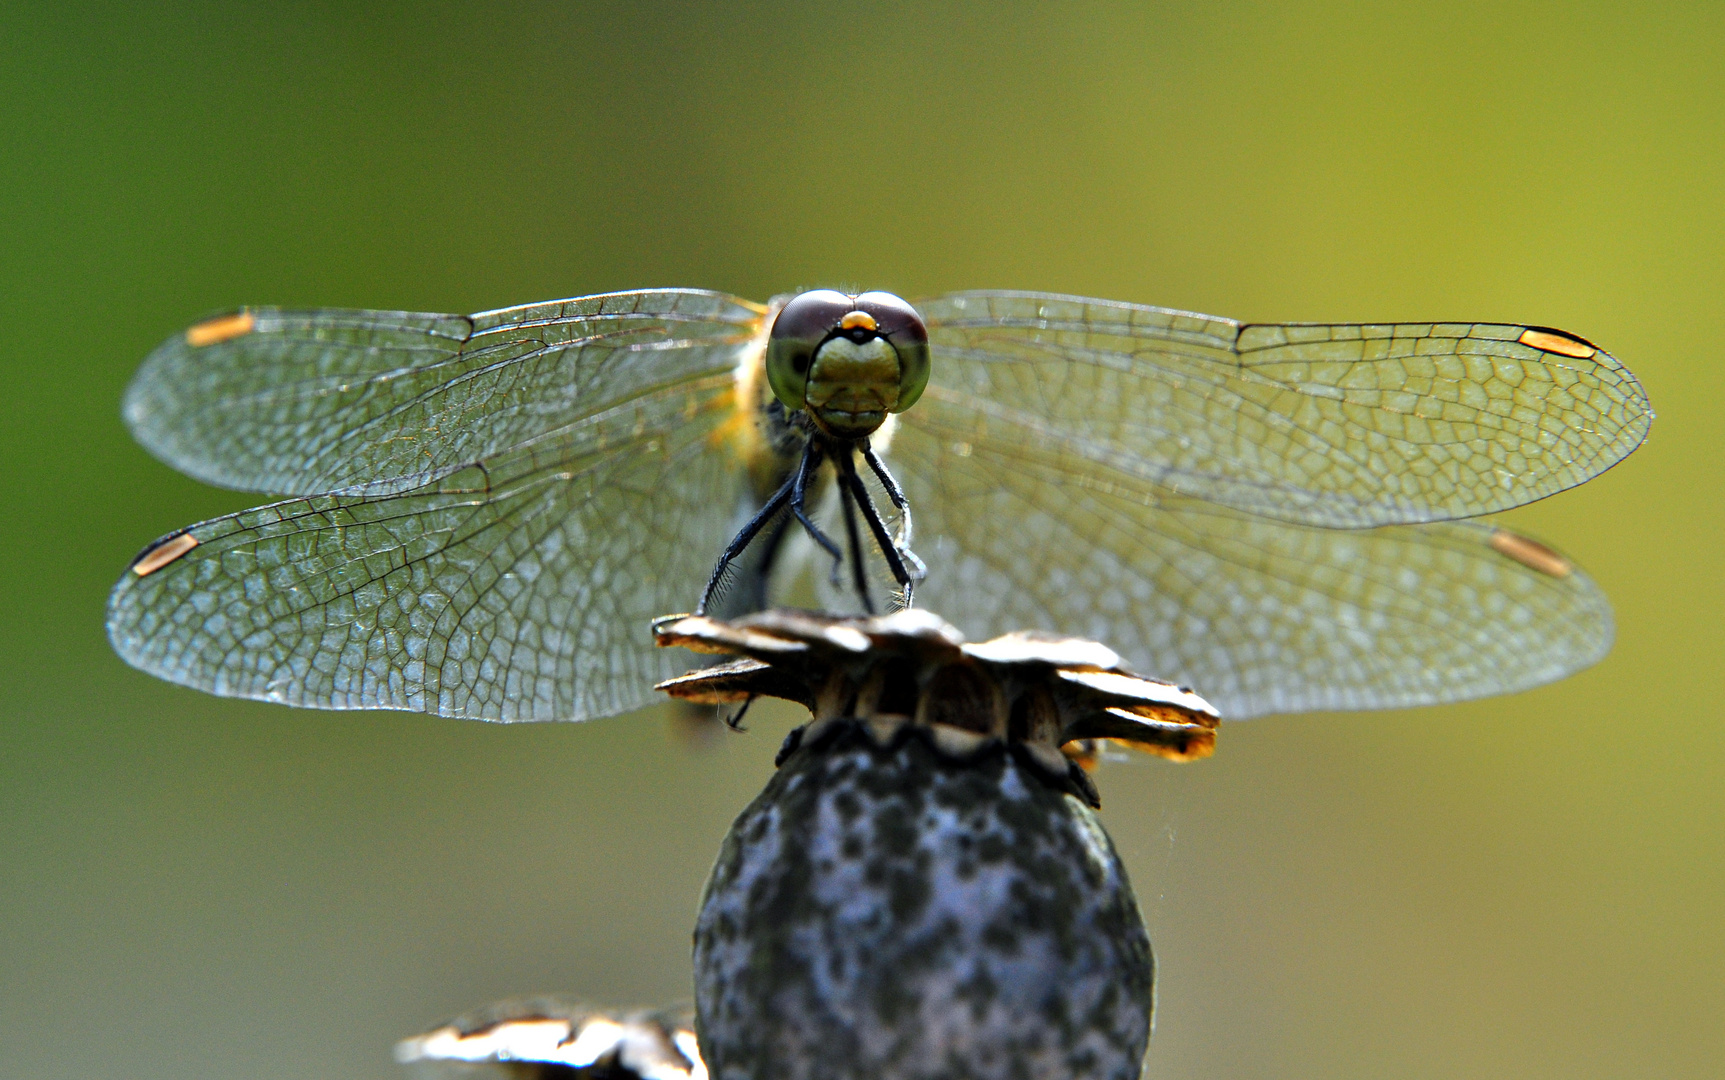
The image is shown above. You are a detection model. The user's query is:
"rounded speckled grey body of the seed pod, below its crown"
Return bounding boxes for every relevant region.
[695,721,1152,1080]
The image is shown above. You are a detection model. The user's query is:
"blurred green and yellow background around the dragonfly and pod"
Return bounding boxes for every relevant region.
[0,2,1725,1080]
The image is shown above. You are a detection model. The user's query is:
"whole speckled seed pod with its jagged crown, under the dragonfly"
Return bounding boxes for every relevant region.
[661,612,1214,1080]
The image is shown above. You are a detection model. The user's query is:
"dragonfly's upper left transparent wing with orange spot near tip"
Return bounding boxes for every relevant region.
[124,290,762,495]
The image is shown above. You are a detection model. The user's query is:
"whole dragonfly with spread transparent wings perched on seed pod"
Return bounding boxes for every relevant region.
[107,288,1653,721]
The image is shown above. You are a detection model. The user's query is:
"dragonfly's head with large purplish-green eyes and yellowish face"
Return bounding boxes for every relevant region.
[766,288,928,438]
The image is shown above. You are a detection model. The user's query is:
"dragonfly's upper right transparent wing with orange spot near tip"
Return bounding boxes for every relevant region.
[907,292,1653,528]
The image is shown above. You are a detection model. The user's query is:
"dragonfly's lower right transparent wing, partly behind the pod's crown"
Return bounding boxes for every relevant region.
[890,405,1611,718]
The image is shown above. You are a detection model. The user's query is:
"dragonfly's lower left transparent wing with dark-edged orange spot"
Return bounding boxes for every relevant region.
[109,371,742,719]
